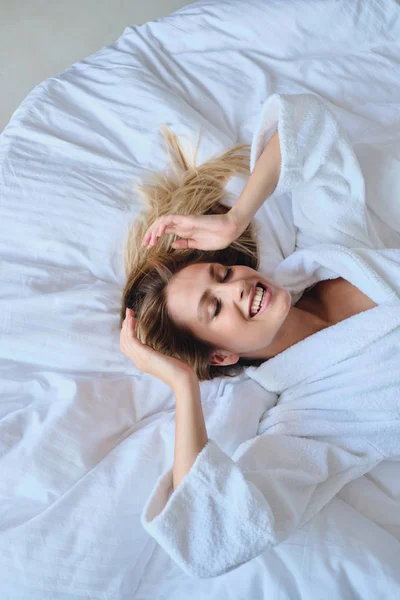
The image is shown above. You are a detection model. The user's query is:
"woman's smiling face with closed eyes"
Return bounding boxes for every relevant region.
[166,263,291,365]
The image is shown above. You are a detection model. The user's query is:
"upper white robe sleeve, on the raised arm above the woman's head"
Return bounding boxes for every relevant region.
[250,94,380,249]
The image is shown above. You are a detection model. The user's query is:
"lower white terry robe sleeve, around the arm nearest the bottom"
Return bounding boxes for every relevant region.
[141,434,383,578]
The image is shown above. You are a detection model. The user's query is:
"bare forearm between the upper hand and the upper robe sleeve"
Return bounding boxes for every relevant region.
[229,131,281,231]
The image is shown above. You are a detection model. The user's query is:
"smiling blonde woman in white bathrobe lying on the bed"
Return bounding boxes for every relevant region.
[121,94,400,577]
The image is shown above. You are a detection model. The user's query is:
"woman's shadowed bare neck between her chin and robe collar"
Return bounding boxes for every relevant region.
[242,300,330,358]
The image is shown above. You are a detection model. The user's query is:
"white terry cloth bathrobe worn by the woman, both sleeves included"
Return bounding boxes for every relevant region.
[142,94,400,577]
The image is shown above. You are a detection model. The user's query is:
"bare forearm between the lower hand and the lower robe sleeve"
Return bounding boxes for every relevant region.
[173,377,208,490]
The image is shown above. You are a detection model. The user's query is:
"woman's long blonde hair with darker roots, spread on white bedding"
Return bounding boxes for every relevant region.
[120,127,263,381]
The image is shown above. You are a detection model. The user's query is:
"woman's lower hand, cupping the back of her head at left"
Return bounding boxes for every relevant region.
[120,308,197,390]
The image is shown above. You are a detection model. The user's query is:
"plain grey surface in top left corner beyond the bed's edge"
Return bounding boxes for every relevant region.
[0,0,191,132]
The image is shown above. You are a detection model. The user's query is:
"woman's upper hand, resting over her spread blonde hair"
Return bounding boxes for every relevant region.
[142,211,248,250]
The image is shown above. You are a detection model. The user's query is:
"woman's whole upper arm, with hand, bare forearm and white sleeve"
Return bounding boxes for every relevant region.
[143,94,374,255]
